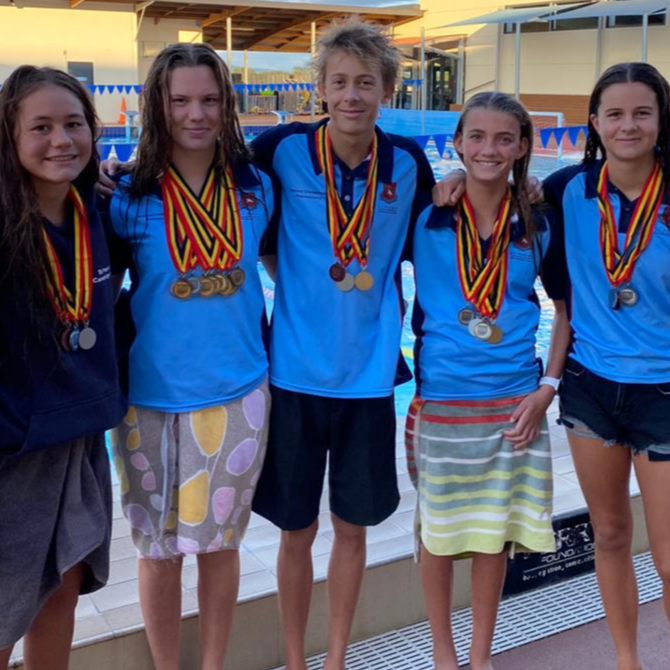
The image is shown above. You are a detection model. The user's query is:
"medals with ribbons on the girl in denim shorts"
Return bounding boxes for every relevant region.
[598,163,664,310]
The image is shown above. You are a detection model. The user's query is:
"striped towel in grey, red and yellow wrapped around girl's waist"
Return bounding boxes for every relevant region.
[405,397,556,557]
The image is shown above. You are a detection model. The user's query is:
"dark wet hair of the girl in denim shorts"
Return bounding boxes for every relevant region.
[584,63,670,192]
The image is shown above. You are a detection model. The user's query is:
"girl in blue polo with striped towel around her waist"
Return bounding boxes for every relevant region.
[407,93,569,670]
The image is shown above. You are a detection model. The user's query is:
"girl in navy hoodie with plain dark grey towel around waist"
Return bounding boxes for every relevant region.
[0,66,125,670]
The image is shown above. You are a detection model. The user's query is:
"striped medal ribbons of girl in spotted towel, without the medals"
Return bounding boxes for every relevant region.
[161,166,243,275]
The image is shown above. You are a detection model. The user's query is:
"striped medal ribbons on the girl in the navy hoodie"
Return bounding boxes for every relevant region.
[42,185,93,324]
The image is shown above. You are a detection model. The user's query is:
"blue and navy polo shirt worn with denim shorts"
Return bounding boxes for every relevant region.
[544,161,670,384]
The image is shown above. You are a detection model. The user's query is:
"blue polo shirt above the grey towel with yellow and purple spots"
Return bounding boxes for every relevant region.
[109,164,274,413]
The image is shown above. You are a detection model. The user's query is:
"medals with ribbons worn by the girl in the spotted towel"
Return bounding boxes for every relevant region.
[161,165,246,300]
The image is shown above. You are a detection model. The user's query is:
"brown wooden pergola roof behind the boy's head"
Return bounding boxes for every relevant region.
[70,0,423,52]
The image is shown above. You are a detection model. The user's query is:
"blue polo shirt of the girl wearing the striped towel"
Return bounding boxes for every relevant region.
[412,205,566,400]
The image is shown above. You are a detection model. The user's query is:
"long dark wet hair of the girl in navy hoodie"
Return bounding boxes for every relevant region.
[0,65,101,325]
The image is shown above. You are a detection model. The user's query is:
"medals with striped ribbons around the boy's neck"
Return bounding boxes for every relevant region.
[316,125,379,293]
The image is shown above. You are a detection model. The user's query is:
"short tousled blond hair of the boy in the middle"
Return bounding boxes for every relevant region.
[312,16,402,91]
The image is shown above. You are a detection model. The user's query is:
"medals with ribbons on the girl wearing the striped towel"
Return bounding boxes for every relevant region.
[456,191,512,344]
